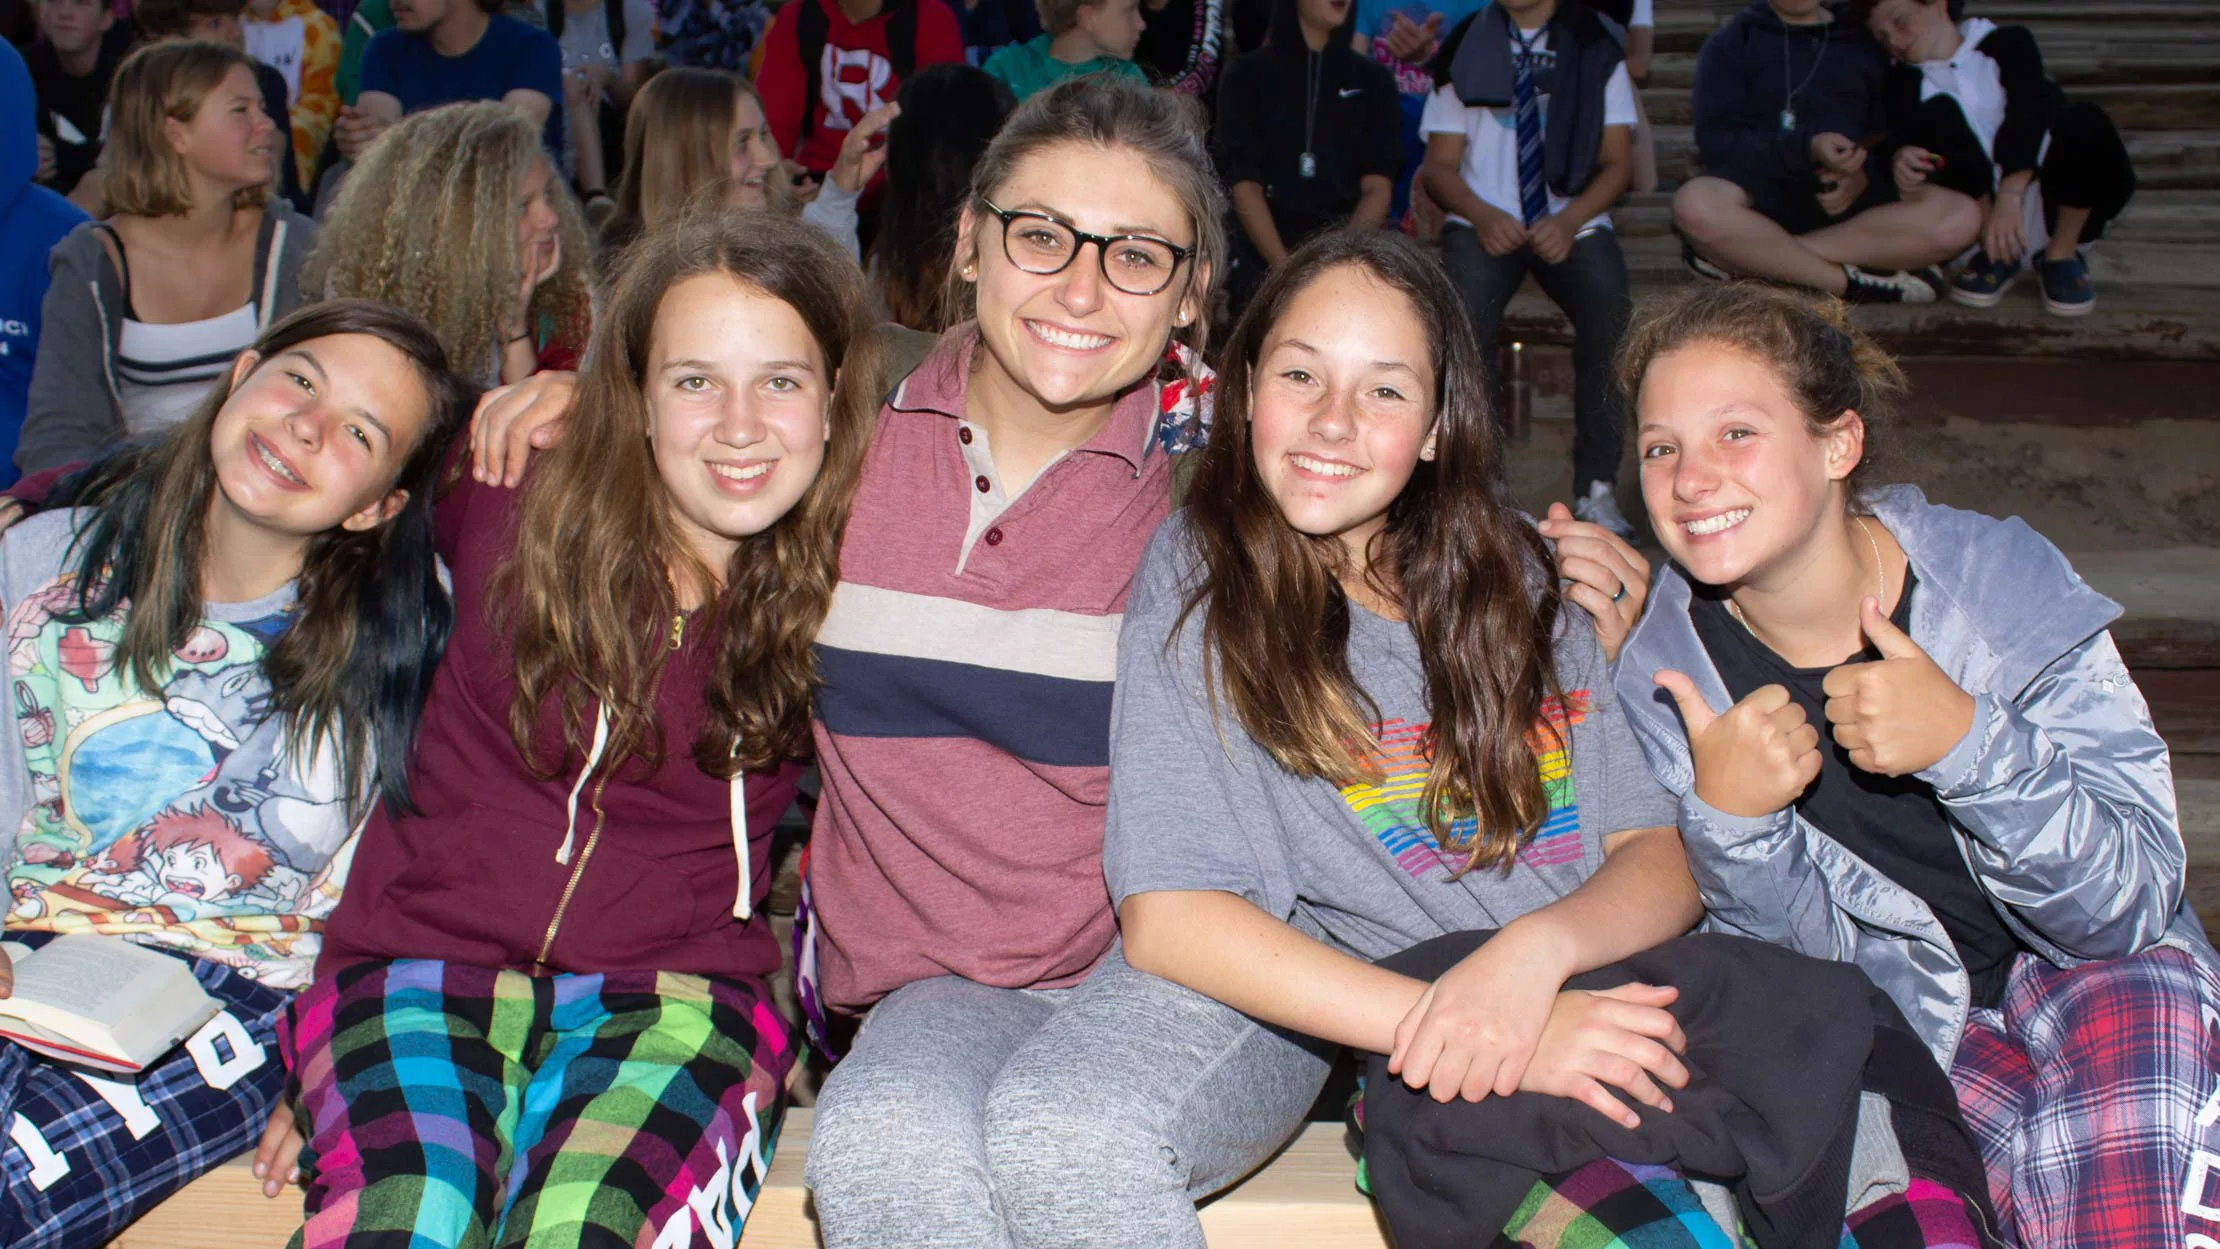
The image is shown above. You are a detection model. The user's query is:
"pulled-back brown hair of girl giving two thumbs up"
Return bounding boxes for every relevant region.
[1618,282,1907,510]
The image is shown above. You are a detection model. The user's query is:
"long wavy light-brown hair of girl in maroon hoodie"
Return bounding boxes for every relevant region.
[491,211,879,776]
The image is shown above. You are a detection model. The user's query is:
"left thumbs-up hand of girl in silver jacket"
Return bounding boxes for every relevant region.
[1654,668,1818,816]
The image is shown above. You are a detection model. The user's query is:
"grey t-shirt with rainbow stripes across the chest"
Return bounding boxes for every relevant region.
[1106,515,1676,958]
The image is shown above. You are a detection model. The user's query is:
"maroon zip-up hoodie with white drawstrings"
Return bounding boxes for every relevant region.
[317,477,799,978]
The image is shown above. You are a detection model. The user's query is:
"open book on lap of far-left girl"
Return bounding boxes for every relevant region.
[0,934,220,1074]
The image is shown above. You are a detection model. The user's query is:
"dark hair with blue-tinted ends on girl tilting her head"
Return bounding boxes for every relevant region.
[58,299,477,814]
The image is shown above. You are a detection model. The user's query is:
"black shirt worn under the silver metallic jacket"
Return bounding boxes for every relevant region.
[1689,568,2020,1007]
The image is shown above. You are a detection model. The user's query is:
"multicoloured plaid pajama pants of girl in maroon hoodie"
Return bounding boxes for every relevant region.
[291,958,793,1249]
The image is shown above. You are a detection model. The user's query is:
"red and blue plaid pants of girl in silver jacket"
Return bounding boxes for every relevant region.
[1951,947,2220,1249]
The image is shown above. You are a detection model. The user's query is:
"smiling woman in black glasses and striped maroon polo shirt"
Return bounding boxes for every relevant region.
[806,78,1325,1249]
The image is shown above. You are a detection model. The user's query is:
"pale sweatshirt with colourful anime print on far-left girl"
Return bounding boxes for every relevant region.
[0,512,353,987]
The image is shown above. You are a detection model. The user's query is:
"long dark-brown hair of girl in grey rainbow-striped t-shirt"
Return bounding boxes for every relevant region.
[1181,231,1565,870]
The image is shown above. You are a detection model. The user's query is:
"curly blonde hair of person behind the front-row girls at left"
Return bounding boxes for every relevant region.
[302,100,593,377]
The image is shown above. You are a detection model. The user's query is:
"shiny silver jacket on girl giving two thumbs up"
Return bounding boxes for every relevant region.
[1614,486,2220,1069]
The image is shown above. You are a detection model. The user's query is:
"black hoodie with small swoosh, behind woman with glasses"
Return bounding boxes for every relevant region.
[1219,42,1403,248]
